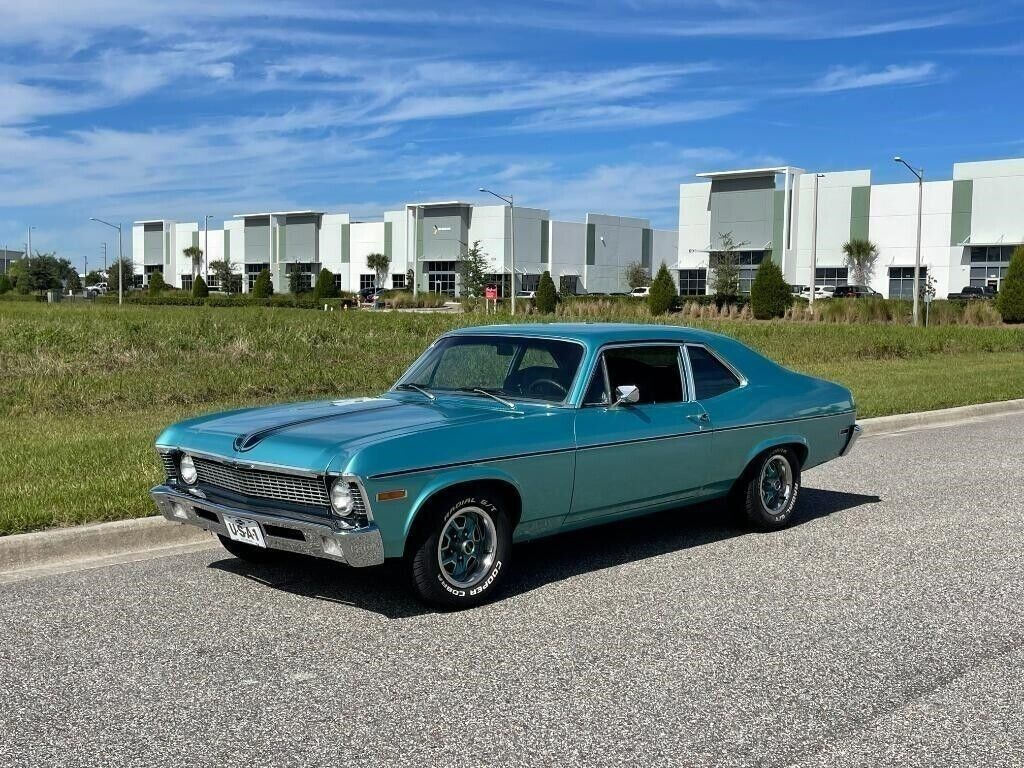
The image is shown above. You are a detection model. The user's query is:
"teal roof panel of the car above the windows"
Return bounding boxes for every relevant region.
[445,323,722,346]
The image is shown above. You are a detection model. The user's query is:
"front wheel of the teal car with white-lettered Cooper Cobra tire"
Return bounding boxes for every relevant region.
[410,494,512,610]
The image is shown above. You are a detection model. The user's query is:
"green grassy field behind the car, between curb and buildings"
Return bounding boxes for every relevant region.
[6,303,1024,534]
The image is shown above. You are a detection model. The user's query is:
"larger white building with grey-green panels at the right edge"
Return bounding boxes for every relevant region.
[678,159,1024,298]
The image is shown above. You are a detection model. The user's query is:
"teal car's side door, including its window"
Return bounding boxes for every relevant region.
[566,343,712,525]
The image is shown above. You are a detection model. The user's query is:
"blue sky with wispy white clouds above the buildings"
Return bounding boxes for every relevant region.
[0,0,1024,274]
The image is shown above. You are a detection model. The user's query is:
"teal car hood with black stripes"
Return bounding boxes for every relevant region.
[157,394,522,472]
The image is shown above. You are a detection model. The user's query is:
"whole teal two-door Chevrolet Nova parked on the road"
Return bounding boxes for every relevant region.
[152,324,860,608]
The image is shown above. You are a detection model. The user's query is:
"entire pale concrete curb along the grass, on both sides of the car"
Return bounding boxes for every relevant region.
[6,399,1024,583]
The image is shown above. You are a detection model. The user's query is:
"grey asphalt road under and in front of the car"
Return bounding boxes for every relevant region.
[0,416,1024,766]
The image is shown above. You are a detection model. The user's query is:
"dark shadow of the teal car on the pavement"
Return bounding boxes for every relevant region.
[209,487,881,618]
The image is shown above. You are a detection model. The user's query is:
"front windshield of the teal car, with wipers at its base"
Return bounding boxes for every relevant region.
[396,336,583,402]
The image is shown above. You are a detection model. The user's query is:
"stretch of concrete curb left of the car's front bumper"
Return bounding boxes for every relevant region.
[0,515,215,573]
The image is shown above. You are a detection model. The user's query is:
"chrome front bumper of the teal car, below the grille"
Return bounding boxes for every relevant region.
[150,485,384,567]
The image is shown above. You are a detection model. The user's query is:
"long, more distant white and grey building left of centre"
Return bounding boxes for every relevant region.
[132,201,678,295]
